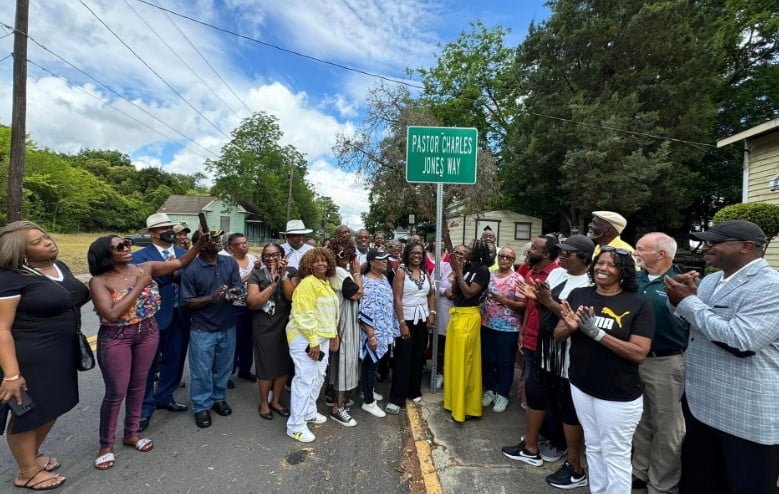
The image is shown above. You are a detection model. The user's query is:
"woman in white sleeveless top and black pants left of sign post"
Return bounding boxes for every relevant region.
[386,241,436,414]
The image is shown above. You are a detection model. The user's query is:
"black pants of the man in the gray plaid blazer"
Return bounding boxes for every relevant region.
[679,398,779,494]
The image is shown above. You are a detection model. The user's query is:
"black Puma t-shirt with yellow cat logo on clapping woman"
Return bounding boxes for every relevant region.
[568,286,655,401]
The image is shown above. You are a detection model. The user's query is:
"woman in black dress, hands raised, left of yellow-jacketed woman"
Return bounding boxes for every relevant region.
[246,243,297,420]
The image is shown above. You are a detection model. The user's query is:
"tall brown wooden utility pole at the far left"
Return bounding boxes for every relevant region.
[6,0,30,222]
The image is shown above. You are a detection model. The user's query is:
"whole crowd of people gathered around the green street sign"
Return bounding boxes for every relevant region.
[0,211,779,494]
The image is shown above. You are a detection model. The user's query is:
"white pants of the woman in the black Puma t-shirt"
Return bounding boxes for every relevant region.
[571,384,644,494]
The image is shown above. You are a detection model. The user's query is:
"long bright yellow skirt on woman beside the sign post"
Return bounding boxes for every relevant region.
[444,307,482,422]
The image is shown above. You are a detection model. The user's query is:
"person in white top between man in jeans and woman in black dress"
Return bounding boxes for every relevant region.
[226,233,260,385]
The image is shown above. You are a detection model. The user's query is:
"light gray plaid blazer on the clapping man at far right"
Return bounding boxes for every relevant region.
[675,259,779,445]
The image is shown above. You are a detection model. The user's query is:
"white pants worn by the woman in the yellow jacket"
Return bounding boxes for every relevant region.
[287,334,330,432]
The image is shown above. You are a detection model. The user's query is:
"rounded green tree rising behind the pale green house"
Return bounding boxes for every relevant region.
[206,112,319,231]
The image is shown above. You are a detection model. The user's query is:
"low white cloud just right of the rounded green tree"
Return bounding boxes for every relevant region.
[306,160,368,229]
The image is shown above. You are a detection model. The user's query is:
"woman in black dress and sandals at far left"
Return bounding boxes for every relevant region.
[0,221,89,490]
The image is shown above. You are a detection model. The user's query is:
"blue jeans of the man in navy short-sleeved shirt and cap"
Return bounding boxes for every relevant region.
[189,326,235,413]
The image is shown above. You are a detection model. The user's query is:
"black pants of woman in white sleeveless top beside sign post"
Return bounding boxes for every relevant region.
[389,321,427,406]
